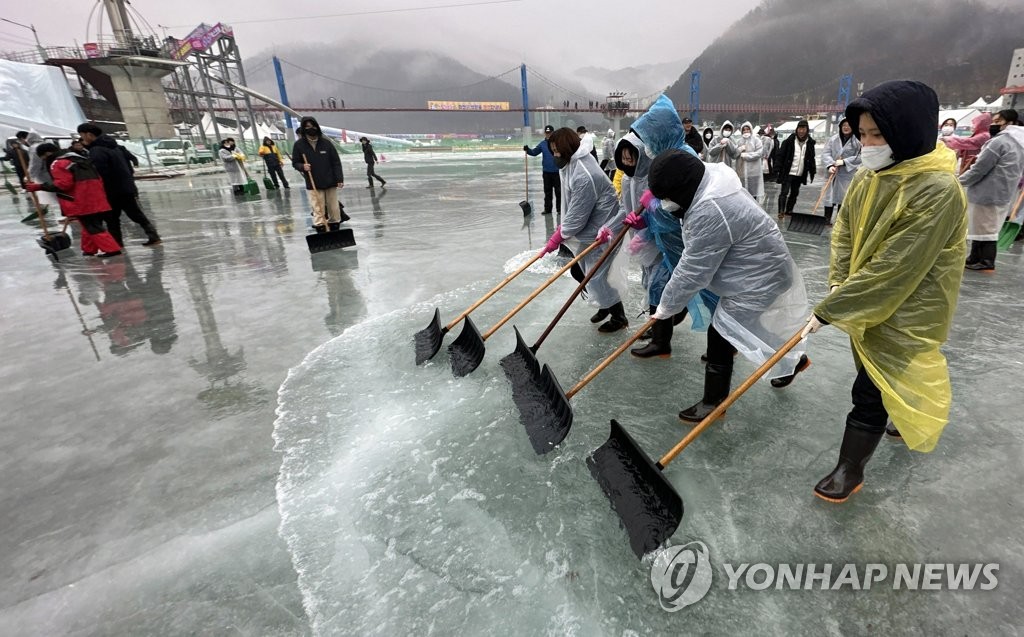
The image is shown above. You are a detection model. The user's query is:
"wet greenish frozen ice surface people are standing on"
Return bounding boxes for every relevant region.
[0,153,1024,635]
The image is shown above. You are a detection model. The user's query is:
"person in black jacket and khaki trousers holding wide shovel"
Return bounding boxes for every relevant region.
[292,117,345,232]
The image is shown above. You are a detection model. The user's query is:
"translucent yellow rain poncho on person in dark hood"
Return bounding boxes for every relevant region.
[814,144,967,452]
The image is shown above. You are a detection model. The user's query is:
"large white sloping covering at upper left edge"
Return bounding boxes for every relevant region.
[0,59,86,139]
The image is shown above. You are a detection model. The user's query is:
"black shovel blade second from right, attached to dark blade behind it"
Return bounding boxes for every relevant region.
[513,365,572,456]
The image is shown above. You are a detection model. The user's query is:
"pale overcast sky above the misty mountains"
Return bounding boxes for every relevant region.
[0,0,760,73]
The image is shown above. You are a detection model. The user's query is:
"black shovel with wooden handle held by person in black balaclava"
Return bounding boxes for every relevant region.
[513,319,656,456]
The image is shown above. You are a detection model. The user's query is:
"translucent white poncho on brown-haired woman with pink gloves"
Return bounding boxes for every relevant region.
[558,135,629,308]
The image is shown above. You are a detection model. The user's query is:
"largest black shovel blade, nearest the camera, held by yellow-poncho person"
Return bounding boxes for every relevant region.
[587,420,683,558]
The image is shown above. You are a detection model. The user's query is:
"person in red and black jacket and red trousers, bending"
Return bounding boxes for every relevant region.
[25,143,121,257]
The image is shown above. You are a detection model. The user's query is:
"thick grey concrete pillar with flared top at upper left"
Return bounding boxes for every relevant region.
[90,57,180,139]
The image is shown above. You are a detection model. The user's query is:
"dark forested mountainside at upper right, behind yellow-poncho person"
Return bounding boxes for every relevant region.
[668,0,1022,116]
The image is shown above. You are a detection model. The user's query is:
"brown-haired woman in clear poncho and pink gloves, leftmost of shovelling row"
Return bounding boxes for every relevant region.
[541,128,629,333]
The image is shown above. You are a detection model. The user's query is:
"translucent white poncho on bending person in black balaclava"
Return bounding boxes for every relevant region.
[650,158,808,378]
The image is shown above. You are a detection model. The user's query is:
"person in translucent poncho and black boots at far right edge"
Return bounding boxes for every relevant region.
[959,109,1024,272]
